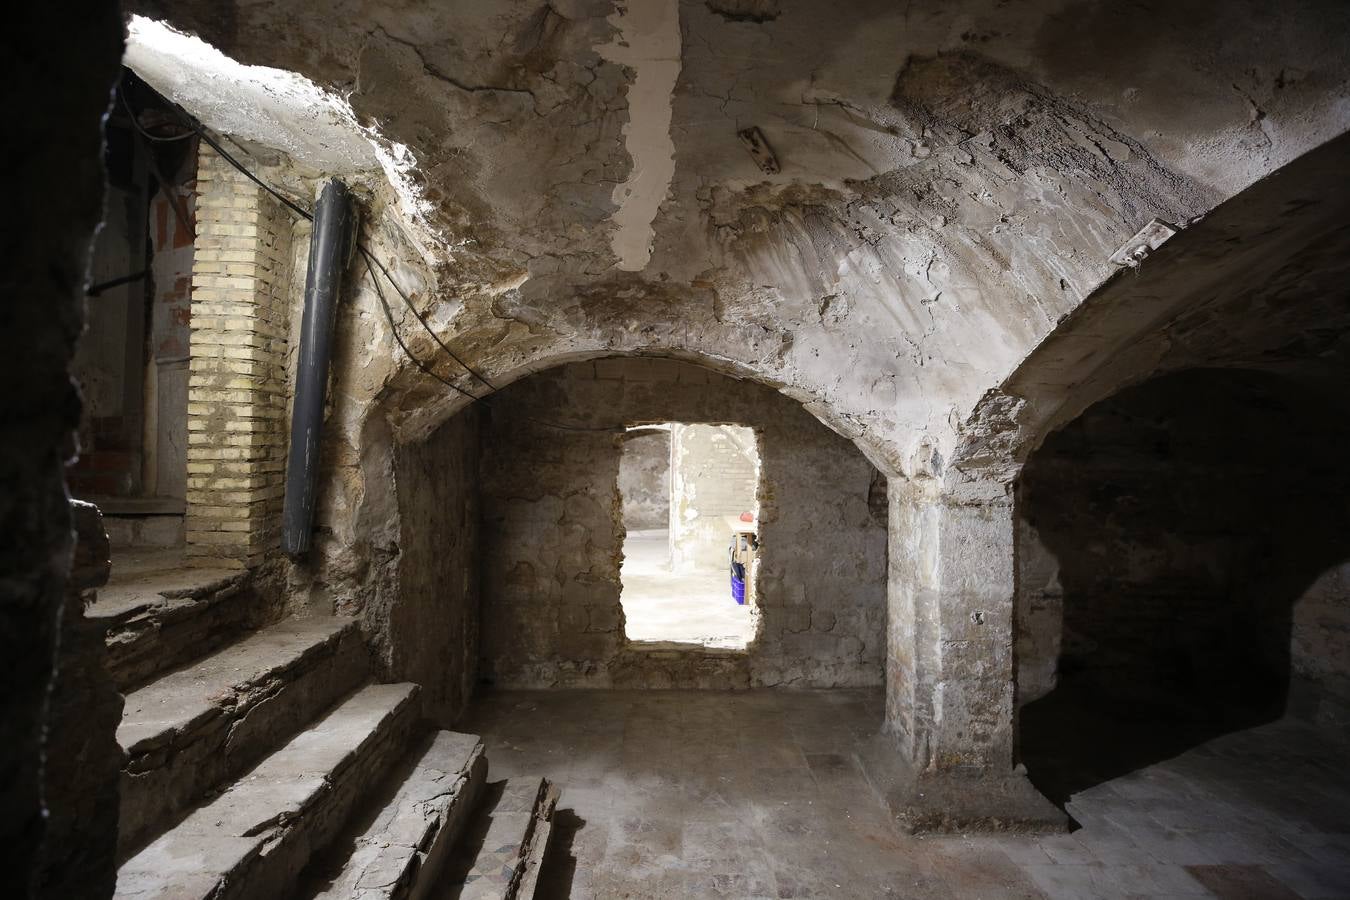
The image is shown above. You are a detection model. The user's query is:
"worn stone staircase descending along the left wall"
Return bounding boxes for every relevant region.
[89,558,558,900]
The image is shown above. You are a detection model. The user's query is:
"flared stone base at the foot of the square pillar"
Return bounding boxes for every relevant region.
[859,735,1069,834]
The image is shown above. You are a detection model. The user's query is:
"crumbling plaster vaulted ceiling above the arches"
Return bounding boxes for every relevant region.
[121,0,1350,493]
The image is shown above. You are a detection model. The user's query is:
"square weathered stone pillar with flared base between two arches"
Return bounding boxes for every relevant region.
[886,479,1065,830]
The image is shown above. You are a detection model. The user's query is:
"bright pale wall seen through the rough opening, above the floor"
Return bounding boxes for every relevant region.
[671,424,760,572]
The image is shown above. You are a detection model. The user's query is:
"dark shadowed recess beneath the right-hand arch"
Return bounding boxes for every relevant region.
[1015,367,1350,801]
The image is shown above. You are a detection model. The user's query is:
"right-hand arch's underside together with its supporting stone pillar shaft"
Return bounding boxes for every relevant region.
[864,130,1350,819]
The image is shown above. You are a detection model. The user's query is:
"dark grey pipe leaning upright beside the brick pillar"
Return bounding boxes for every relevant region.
[281,179,356,556]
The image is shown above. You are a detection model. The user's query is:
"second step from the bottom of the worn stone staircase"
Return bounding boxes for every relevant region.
[301,731,487,900]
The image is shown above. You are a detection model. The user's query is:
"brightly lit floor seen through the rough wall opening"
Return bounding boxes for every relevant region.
[620,529,755,649]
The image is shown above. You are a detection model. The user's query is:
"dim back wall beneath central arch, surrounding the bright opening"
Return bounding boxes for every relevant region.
[366,354,887,716]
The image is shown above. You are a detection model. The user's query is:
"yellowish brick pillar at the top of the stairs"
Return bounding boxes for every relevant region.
[188,144,292,567]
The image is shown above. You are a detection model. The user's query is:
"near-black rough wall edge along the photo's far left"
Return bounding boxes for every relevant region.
[0,3,122,896]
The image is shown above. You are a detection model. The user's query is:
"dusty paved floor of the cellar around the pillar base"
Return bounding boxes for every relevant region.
[462,691,1350,900]
